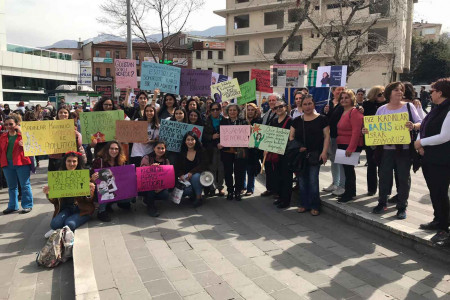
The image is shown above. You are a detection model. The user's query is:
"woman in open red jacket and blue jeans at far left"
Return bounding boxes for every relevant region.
[0,115,33,215]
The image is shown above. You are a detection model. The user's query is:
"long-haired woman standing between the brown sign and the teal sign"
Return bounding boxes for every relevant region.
[130,104,159,166]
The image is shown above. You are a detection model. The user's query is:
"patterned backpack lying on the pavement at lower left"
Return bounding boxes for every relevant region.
[36,226,74,268]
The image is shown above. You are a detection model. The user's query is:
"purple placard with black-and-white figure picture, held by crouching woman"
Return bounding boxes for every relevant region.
[94,165,137,203]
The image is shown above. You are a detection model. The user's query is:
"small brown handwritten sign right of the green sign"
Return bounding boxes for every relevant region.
[116,120,148,143]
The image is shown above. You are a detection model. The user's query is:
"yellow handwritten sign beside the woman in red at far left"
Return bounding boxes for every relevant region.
[21,120,77,156]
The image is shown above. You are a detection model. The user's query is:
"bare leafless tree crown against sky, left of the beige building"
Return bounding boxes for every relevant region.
[98,0,204,62]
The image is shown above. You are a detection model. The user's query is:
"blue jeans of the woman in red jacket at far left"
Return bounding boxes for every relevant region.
[3,160,33,210]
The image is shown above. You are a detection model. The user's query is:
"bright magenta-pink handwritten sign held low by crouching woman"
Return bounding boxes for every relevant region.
[136,165,175,192]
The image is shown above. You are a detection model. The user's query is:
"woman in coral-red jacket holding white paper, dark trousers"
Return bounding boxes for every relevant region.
[335,90,364,203]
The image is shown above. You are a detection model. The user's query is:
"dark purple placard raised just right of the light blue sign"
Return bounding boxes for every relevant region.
[180,69,212,96]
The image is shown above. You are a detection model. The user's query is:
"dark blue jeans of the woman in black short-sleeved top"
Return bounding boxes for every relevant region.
[298,165,320,209]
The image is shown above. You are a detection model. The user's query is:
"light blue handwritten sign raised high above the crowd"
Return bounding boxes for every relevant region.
[140,61,181,95]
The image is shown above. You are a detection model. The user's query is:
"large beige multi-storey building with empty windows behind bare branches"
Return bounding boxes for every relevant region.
[215,0,417,88]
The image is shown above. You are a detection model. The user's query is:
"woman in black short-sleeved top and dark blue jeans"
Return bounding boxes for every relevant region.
[289,97,330,216]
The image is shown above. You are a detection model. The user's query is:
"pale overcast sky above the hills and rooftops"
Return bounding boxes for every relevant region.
[5,0,450,46]
